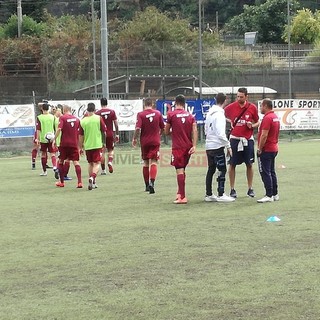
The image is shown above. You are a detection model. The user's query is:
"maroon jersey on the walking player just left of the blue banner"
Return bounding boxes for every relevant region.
[136,109,164,146]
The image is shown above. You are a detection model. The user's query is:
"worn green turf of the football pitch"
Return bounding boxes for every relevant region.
[0,141,320,320]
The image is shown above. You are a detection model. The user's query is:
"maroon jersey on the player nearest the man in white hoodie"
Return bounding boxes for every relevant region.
[167,109,196,149]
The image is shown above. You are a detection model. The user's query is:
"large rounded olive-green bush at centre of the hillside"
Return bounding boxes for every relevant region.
[118,7,206,70]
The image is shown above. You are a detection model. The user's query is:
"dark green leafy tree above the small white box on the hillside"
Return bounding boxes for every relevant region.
[225,0,299,43]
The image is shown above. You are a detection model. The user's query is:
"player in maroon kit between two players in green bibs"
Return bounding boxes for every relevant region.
[54,105,82,188]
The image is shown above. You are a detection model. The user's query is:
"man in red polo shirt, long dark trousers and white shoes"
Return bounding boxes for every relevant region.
[257,99,280,203]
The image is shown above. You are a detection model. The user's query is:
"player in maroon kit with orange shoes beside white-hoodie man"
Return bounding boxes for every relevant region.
[164,95,198,204]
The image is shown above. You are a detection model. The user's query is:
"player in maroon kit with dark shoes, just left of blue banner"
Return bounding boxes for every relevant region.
[132,98,164,194]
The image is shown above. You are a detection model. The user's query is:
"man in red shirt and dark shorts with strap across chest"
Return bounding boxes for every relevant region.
[224,88,259,198]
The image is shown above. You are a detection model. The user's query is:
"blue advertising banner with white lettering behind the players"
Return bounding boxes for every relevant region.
[156,99,216,124]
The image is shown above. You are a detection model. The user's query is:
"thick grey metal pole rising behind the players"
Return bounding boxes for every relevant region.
[100,0,109,99]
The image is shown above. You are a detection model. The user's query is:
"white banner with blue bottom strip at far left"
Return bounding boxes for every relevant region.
[0,104,35,138]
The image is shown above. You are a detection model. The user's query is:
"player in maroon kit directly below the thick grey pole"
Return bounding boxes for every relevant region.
[96,98,119,175]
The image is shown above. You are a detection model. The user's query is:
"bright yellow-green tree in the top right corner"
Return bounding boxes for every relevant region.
[284,9,320,44]
